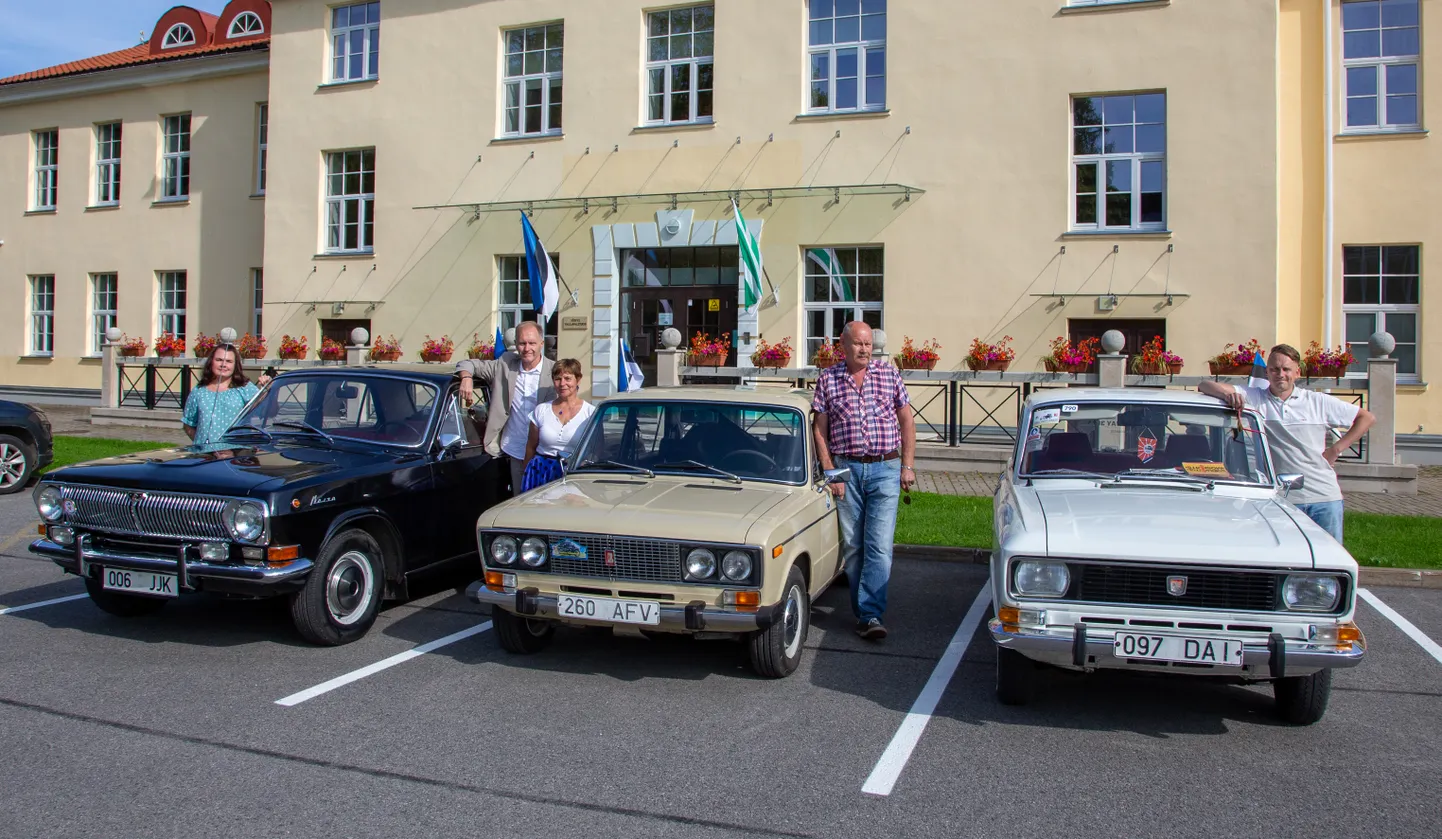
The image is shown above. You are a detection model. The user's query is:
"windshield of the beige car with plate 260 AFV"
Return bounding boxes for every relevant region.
[571,399,808,484]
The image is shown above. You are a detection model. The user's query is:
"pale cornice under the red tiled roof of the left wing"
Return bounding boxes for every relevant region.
[0,49,270,107]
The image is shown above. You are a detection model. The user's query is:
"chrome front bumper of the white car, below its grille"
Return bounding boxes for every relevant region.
[988,618,1367,679]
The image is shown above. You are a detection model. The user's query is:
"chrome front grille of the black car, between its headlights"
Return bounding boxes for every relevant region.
[59,484,231,539]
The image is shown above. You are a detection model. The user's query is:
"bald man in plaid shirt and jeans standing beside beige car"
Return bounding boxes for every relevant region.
[812,320,916,640]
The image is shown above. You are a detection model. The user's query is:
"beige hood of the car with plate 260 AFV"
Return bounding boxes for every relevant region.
[477,476,796,543]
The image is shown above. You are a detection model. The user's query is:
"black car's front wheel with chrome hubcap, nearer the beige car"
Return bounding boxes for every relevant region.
[290,529,385,647]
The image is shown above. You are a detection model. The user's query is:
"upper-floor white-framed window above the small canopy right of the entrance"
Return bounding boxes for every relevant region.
[1071,92,1167,231]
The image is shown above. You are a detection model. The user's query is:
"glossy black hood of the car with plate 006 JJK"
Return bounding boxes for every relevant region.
[45,443,418,496]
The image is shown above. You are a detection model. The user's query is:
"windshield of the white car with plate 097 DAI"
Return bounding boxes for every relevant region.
[1021,402,1272,484]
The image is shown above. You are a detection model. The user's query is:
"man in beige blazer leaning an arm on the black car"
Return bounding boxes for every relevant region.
[456,320,555,497]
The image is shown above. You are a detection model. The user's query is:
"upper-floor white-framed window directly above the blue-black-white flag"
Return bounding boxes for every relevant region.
[502,23,564,137]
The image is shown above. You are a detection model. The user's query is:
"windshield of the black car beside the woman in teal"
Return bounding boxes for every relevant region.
[226,373,437,445]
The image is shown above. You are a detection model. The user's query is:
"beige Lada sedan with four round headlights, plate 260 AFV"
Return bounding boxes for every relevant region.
[467,388,842,678]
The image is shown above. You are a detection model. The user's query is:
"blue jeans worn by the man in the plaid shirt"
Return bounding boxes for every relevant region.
[836,457,901,621]
